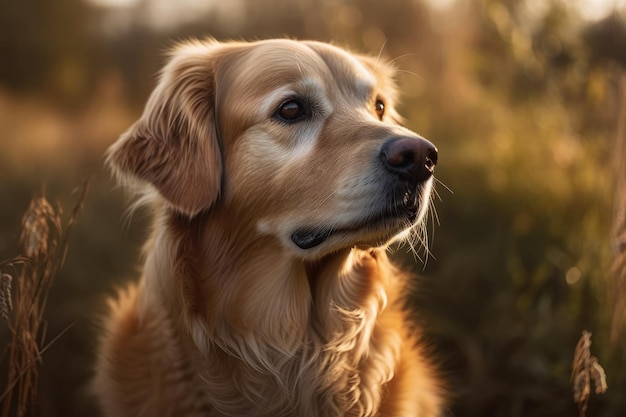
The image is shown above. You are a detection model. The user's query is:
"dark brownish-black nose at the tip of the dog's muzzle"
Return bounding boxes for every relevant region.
[380,136,437,184]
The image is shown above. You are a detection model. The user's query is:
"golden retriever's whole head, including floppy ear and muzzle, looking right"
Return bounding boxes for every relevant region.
[109,40,437,259]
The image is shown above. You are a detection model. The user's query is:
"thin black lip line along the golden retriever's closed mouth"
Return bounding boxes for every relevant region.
[291,193,419,249]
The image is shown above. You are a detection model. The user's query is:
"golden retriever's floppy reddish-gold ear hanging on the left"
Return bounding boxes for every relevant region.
[107,42,222,216]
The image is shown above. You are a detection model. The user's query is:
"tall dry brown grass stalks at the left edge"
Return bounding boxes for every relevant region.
[0,182,88,417]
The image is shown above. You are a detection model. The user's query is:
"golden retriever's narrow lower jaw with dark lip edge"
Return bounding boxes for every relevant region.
[291,203,416,251]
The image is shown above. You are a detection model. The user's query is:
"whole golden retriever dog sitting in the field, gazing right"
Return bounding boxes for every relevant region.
[95,39,443,417]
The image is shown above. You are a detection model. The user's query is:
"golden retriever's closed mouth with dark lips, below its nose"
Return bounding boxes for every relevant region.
[291,190,421,250]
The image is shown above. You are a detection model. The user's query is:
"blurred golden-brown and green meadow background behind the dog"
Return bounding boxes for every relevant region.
[0,0,626,417]
